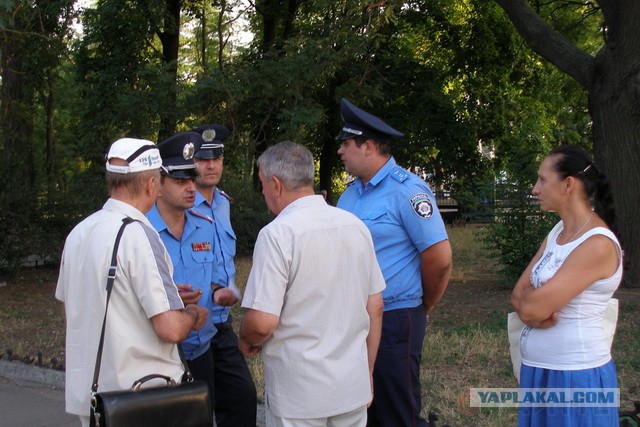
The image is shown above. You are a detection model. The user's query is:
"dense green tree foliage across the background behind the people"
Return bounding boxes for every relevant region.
[0,0,601,276]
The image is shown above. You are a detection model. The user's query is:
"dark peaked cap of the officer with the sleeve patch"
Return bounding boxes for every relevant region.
[336,98,404,142]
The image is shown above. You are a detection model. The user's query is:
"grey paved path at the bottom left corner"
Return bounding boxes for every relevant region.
[0,359,264,427]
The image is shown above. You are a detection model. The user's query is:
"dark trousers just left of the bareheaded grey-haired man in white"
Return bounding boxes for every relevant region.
[211,316,257,427]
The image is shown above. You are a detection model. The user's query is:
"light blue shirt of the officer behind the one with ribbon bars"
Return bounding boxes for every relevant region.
[193,188,237,323]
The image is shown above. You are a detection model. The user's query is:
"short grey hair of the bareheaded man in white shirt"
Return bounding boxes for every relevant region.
[258,141,315,191]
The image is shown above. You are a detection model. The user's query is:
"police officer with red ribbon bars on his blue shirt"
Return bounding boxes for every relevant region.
[147,132,219,418]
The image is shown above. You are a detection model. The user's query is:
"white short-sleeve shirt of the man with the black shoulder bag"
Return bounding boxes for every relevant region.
[56,199,184,416]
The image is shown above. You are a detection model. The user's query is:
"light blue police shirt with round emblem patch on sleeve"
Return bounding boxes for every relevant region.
[338,157,448,311]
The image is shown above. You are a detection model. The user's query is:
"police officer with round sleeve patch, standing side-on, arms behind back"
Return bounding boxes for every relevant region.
[336,98,451,426]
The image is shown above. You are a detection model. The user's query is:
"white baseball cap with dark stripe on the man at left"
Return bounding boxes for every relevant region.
[106,138,162,173]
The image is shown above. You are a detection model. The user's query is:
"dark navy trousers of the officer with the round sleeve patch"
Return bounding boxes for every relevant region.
[367,304,427,427]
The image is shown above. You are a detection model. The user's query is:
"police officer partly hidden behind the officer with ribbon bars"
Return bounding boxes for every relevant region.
[194,125,257,427]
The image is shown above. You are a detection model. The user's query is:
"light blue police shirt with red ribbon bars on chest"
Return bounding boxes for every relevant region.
[147,205,218,360]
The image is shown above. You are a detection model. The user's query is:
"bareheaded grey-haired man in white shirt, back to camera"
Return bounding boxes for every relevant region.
[240,142,385,426]
